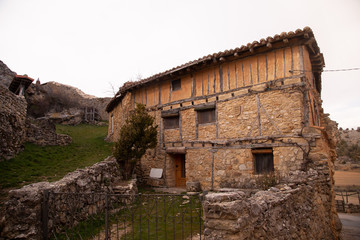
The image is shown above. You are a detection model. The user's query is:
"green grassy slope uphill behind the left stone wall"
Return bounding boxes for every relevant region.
[0,124,112,190]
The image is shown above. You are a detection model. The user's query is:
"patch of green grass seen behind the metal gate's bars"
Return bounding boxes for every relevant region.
[52,192,204,239]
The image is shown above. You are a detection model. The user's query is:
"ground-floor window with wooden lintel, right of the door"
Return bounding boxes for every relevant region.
[252,148,274,174]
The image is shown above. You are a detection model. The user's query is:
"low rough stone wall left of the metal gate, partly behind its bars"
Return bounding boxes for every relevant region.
[0,157,137,239]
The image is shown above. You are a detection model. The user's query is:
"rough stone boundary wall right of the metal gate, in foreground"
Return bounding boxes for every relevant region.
[203,170,341,240]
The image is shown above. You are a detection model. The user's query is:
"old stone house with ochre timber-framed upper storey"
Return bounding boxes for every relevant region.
[106,27,335,190]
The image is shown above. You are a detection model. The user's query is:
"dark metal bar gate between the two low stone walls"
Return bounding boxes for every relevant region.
[42,191,203,240]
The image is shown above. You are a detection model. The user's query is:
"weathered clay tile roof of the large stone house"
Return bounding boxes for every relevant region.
[106,27,324,112]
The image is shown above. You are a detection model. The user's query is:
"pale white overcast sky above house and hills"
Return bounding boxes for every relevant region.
[0,0,360,128]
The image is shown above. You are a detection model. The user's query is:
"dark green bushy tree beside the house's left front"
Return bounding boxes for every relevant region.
[113,104,157,180]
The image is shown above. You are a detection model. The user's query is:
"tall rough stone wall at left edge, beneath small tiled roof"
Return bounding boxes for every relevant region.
[0,85,26,161]
